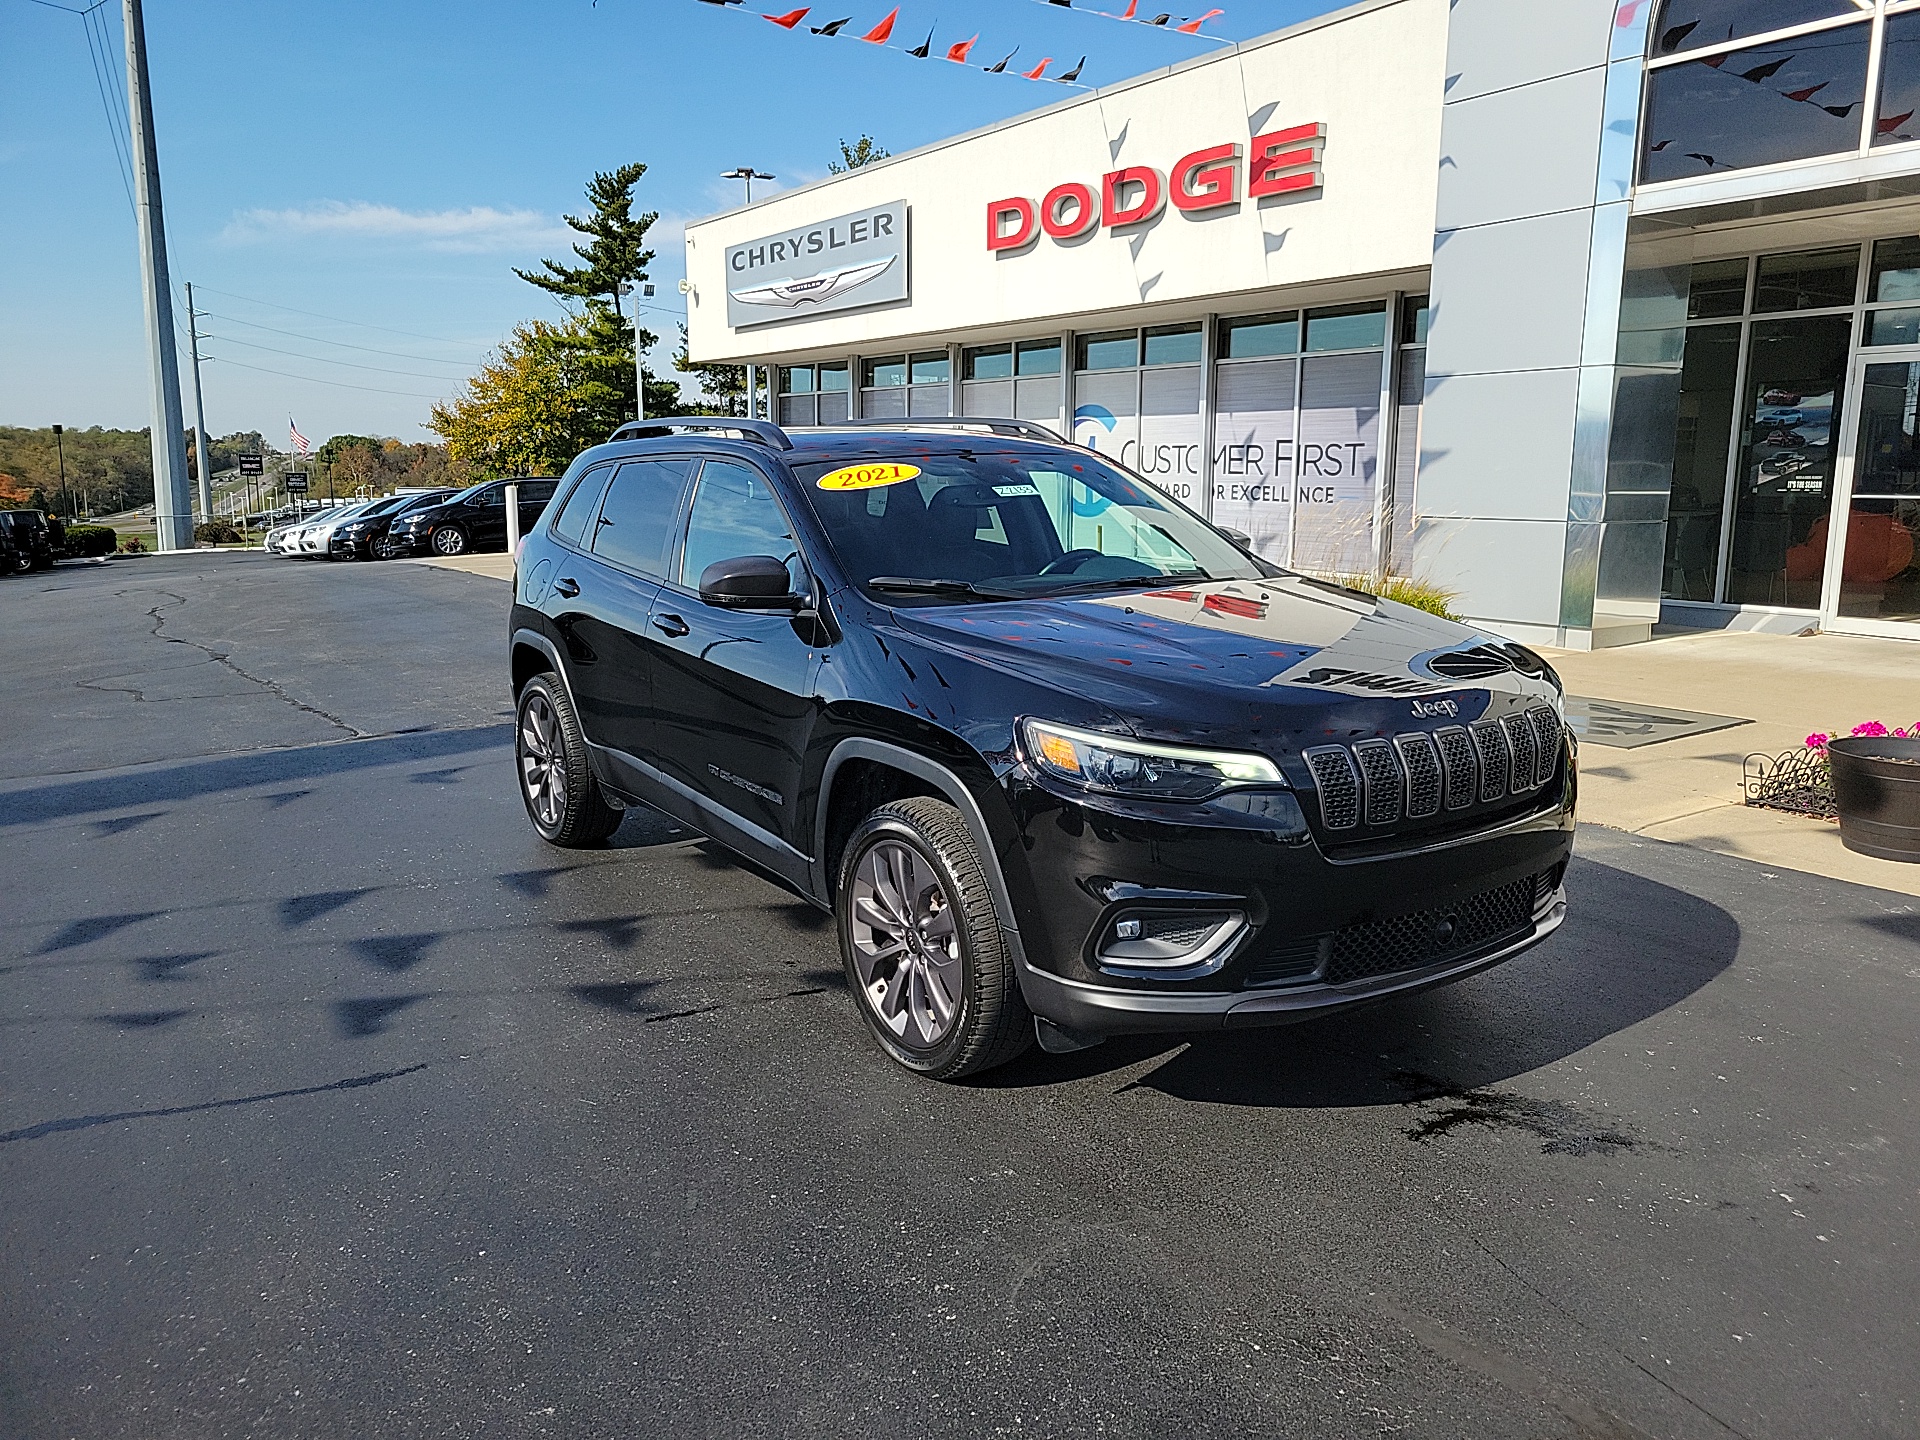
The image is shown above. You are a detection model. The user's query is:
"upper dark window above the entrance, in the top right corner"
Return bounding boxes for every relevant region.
[1640,0,1920,182]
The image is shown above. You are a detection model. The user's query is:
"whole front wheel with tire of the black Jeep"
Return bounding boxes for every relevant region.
[835,797,1033,1081]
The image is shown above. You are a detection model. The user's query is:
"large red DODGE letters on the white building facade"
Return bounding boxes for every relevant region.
[987,125,1327,253]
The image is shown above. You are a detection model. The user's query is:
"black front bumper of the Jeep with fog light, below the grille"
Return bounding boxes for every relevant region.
[1012,783,1572,1048]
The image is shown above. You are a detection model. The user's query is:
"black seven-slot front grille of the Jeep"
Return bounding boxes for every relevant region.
[1304,705,1563,831]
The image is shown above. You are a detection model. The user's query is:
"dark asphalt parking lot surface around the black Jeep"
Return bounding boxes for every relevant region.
[0,553,1920,1440]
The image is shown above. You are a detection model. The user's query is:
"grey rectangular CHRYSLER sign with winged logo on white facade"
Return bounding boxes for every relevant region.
[726,200,906,330]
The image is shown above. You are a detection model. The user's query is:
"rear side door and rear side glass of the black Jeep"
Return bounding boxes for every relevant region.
[547,457,693,789]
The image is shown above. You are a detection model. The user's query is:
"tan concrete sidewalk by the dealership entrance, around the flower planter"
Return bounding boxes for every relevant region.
[1548,630,1920,895]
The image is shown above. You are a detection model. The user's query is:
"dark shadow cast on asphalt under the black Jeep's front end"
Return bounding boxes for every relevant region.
[979,858,1740,1123]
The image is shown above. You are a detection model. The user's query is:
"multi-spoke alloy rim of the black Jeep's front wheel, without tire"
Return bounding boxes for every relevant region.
[852,839,964,1050]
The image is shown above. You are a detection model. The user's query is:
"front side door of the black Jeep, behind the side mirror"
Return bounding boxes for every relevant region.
[647,459,820,883]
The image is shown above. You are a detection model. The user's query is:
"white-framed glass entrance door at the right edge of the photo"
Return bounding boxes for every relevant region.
[1820,346,1920,639]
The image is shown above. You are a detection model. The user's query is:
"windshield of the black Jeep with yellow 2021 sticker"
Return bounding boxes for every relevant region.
[793,449,1263,603]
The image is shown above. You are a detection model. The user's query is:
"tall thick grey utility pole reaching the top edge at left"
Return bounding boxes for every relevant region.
[121,0,194,551]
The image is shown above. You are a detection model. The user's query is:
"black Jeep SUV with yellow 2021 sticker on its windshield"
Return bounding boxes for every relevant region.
[511,420,1574,1079]
